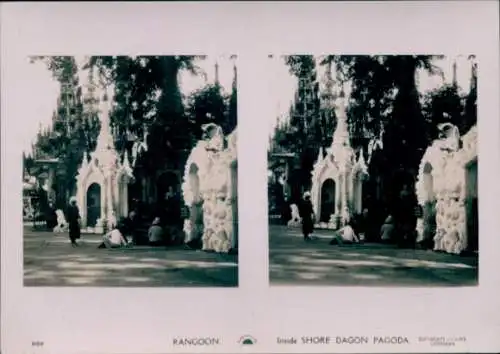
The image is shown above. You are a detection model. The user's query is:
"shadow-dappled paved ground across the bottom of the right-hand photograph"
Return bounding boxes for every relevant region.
[269,225,478,287]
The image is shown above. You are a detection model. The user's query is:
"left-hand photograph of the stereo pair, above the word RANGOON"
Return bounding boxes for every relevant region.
[22,55,238,287]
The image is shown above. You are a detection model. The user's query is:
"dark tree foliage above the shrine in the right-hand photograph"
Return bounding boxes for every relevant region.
[273,55,468,206]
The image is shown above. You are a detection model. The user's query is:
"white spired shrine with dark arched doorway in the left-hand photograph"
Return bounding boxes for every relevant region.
[76,89,134,233]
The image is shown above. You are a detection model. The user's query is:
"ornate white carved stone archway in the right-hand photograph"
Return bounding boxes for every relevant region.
[415,123,477,254]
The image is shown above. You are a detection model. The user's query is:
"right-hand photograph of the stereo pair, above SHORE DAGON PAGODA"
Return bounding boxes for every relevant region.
[268,54,479,287]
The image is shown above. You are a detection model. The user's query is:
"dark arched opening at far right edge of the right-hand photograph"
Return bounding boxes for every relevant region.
[465,160,479,251]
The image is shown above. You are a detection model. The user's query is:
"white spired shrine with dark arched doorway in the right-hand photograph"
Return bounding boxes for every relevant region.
[311,81,368,229]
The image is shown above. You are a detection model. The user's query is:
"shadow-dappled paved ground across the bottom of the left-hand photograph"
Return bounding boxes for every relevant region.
[24,227,238,287]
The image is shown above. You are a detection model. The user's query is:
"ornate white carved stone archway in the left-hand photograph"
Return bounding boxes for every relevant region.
[182,123,238,252]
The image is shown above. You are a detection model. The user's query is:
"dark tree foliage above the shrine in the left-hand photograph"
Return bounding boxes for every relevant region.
[27,56,237,205]
